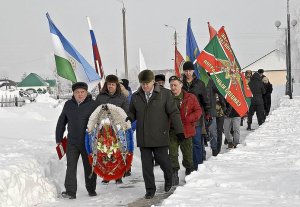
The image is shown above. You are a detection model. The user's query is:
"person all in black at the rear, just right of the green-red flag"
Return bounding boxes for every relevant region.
[247,73,266,130]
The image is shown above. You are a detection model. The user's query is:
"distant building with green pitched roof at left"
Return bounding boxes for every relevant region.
[17,73,56,93]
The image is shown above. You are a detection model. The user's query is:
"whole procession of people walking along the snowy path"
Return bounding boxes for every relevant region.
[56,61,273,199]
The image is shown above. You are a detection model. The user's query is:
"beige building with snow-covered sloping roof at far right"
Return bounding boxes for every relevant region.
[242,49,286,85]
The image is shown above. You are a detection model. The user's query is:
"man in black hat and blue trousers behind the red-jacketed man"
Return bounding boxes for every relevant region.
[183,61,211,170]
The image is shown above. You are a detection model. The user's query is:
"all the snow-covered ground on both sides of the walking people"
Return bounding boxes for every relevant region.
[0,86,300,207]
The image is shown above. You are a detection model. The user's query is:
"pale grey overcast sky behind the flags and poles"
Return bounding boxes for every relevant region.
[0,0,300,81]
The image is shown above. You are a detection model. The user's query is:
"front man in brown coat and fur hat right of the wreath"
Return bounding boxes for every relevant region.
[128,70,184,199]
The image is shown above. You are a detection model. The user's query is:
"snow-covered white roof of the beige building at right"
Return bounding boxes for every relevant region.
[242,49,286,71]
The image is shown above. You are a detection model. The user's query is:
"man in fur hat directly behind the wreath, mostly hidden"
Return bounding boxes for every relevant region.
[96,75,129,184]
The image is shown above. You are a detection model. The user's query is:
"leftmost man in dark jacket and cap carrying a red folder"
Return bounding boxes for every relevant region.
[56,82,97,199]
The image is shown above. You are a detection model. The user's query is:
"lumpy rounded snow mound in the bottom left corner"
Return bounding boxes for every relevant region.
[0,153,56,207]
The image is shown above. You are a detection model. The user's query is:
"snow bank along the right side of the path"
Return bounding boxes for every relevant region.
[163,97,300,207]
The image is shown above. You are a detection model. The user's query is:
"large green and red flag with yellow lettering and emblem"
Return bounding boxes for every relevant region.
[197,32,248,117]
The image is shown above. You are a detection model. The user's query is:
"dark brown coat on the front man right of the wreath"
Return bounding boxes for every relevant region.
[129,84,183,147]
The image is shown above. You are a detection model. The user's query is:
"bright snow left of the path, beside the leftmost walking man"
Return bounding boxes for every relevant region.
[0,102,65,207]
